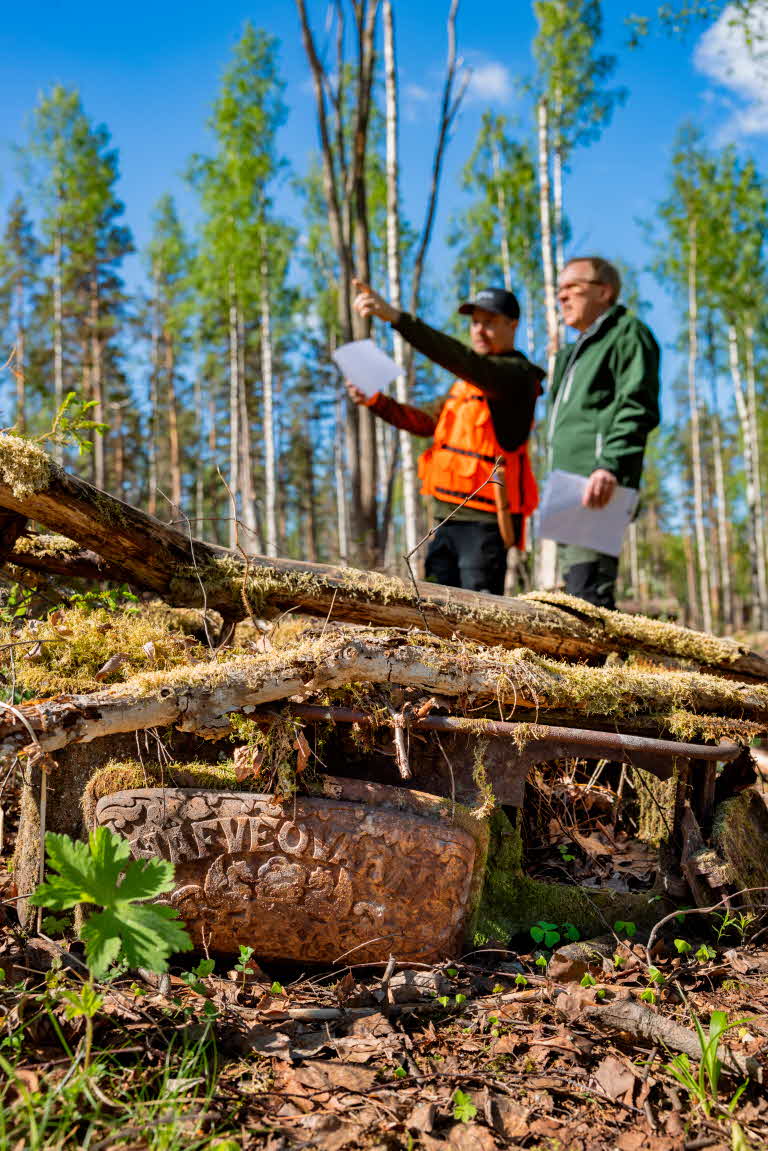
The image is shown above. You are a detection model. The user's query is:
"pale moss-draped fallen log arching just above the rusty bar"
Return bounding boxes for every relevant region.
[0,630,768,756]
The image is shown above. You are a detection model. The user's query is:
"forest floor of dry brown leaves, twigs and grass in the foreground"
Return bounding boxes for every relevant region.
[0,764,768,1151]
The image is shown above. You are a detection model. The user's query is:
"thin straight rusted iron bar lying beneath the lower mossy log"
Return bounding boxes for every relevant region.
[282,703,740,767]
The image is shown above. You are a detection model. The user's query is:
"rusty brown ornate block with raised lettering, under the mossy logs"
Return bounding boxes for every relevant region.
[94,778,487,963]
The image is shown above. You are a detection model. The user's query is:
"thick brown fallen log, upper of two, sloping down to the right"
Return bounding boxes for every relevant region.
[0,435,768,680]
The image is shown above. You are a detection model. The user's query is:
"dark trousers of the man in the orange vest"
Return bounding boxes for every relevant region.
[425,517,507,595]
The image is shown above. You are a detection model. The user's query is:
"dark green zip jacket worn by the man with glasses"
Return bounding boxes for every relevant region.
[548,304,660,488]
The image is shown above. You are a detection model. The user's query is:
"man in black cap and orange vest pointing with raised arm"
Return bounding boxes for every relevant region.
[347,280,545,595]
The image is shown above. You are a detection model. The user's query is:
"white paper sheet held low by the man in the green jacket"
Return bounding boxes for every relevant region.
[539,468,638,556]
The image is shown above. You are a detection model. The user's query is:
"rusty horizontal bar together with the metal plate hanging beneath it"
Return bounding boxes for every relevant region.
[280,703,740,807]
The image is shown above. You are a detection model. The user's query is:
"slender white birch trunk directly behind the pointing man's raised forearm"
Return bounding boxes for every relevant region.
[383,0,418,552]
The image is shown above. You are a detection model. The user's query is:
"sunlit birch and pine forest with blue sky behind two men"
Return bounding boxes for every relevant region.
[0,0,768,631]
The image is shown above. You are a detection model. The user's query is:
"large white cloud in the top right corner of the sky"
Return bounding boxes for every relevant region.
[693,5,768,139]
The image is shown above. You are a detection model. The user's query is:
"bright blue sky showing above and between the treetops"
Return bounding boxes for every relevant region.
[0,0,768,386]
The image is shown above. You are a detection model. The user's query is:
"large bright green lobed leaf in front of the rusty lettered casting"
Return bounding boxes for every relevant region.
[31,828,192,980]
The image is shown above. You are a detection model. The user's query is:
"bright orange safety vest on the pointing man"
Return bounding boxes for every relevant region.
[419,380,539,543]
